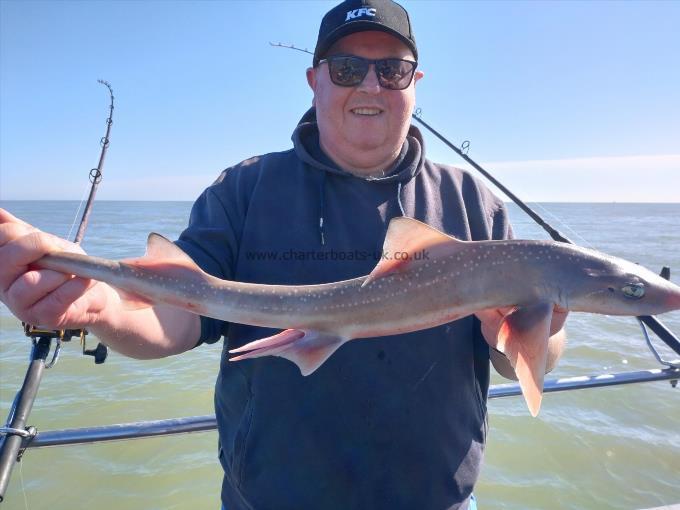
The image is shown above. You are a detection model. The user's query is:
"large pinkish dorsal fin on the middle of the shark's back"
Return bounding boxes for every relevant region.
[362,217,463,286]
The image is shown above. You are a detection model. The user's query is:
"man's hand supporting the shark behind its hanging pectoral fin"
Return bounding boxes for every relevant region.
[475,306,569,380]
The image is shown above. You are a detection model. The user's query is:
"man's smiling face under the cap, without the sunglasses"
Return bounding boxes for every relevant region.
[307,31,423,175]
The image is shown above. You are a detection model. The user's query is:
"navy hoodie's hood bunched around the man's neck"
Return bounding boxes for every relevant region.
[291,107,425,183]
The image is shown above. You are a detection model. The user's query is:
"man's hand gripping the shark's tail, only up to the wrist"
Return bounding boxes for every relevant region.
[0,209,114,329]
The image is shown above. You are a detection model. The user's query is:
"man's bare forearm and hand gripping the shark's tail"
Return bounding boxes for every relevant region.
[0,209,201,359]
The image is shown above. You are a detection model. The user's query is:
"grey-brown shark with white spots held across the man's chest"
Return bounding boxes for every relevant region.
[36,218,680,416]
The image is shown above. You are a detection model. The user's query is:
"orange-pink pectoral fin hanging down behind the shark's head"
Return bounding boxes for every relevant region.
[497,303,553,416]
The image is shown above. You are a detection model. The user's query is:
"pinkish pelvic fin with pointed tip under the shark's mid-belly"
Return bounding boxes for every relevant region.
[229,329,348,375]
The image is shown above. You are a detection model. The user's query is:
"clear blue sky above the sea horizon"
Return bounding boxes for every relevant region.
[0,0,680,202]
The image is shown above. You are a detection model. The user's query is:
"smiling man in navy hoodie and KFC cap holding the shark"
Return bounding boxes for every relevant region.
[0,0,564,510]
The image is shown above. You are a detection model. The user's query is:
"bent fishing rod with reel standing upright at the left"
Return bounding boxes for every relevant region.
[0,80,114,503]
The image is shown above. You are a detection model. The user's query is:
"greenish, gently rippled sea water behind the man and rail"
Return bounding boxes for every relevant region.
[0,201,680,510]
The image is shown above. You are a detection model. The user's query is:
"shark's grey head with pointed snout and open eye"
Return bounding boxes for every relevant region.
[569,257,680,315]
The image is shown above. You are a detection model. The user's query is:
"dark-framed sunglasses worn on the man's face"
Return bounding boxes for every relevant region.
[319,55,418,90]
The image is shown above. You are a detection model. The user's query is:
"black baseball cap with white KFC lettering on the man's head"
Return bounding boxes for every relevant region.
[313,0,418,66]
